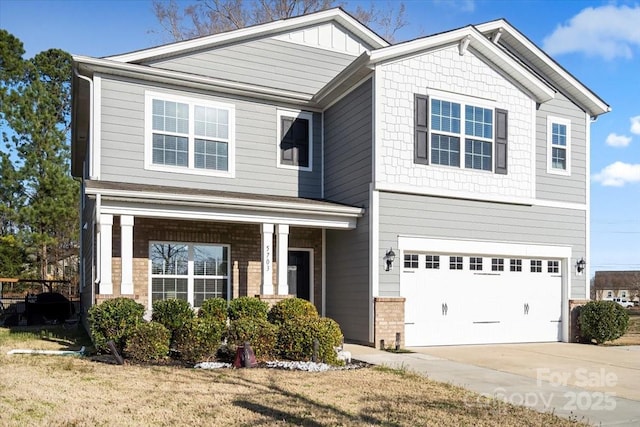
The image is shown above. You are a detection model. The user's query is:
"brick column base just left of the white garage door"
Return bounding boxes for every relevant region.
[373,297,406,348]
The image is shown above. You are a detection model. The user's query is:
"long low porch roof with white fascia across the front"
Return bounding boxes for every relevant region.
[85,181,364,229]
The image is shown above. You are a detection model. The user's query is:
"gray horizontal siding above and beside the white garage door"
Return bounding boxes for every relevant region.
[379,192,586,298]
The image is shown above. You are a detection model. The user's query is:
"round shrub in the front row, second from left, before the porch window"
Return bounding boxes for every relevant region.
[175,317,224,363]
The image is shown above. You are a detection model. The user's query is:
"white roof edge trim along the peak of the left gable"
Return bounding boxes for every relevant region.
[105,8,389,62]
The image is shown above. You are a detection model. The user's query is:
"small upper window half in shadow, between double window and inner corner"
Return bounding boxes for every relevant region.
[278,110,313,171]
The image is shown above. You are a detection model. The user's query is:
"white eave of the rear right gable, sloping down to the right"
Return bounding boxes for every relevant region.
[475,19,611,117]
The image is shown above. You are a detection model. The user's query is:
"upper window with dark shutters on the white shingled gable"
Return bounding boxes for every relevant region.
[415,95,507,174]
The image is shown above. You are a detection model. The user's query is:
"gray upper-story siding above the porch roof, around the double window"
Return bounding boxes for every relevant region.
[100,77,322,198]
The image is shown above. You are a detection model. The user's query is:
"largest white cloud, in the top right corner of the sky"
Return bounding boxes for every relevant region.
[542,5,640,60]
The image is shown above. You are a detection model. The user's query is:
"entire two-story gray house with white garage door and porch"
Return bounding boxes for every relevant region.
[72,9,609,346]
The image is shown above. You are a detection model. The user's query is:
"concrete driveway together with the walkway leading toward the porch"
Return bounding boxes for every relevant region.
[345,343,640,427]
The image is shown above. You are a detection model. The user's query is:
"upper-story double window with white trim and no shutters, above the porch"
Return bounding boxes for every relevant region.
[145,92,235,176]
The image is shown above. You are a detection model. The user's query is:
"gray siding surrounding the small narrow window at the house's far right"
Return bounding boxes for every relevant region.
[536,94,588,203]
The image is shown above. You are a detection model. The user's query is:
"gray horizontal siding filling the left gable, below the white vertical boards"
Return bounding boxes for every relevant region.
[148,39,355,94]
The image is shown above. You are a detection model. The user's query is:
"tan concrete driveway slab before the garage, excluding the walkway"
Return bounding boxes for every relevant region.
[411,342,640,402]
